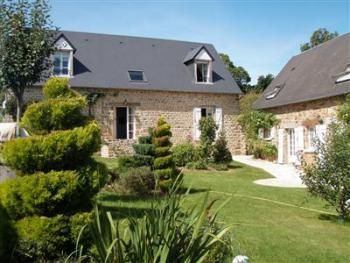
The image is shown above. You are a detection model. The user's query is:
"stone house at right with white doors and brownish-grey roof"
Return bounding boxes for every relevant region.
[254,33,350,165]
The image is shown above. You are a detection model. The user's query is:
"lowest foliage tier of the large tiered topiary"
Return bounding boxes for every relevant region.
[15,215,74,262]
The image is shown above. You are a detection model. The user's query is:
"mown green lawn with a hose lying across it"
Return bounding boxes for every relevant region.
[96,159,350,262]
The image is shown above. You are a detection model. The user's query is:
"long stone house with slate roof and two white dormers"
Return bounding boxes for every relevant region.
[25,31,245,158]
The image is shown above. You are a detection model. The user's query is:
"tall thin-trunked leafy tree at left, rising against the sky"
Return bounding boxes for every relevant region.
[0,0,55,134]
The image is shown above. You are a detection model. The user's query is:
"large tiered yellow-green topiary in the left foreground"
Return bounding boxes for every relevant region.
[0,78,107,262]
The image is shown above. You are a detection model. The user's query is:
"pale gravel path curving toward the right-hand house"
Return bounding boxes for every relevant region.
[233,155,306,188]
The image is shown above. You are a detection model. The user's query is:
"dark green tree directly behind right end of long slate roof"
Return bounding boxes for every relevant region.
[220,53,251,92]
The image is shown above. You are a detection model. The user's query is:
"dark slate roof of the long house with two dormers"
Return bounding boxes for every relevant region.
[45,31,241,94]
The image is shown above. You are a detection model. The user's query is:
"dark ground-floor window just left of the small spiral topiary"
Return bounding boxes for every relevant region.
[116,107,136,140]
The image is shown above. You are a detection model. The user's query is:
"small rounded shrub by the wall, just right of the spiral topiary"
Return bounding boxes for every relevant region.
[172,143,198,167]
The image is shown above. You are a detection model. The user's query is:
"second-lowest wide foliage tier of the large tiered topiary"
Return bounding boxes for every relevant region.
[0,162,107,219]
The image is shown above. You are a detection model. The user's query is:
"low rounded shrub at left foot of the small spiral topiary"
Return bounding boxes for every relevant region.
[120,167,155,195]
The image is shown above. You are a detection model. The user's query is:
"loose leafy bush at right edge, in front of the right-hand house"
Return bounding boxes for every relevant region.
[302,95,350,220]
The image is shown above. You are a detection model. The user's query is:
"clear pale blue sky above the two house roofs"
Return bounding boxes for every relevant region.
[51,0,350,83]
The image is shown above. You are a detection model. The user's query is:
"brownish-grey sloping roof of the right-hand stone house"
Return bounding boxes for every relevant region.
[254,33,350,109]
